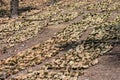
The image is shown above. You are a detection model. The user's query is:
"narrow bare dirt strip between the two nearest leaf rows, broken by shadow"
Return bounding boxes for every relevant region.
[8,24,93,79]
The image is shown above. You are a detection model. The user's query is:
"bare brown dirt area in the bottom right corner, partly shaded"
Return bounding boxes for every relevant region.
[78,44,120,80]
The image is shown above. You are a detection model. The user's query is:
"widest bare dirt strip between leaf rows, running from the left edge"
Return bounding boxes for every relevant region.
[0,24,67,60]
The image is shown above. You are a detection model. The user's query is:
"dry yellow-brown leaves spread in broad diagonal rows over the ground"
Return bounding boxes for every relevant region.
[0,0,120,80]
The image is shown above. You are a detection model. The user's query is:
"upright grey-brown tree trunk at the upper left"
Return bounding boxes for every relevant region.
[10,0,19,18]
